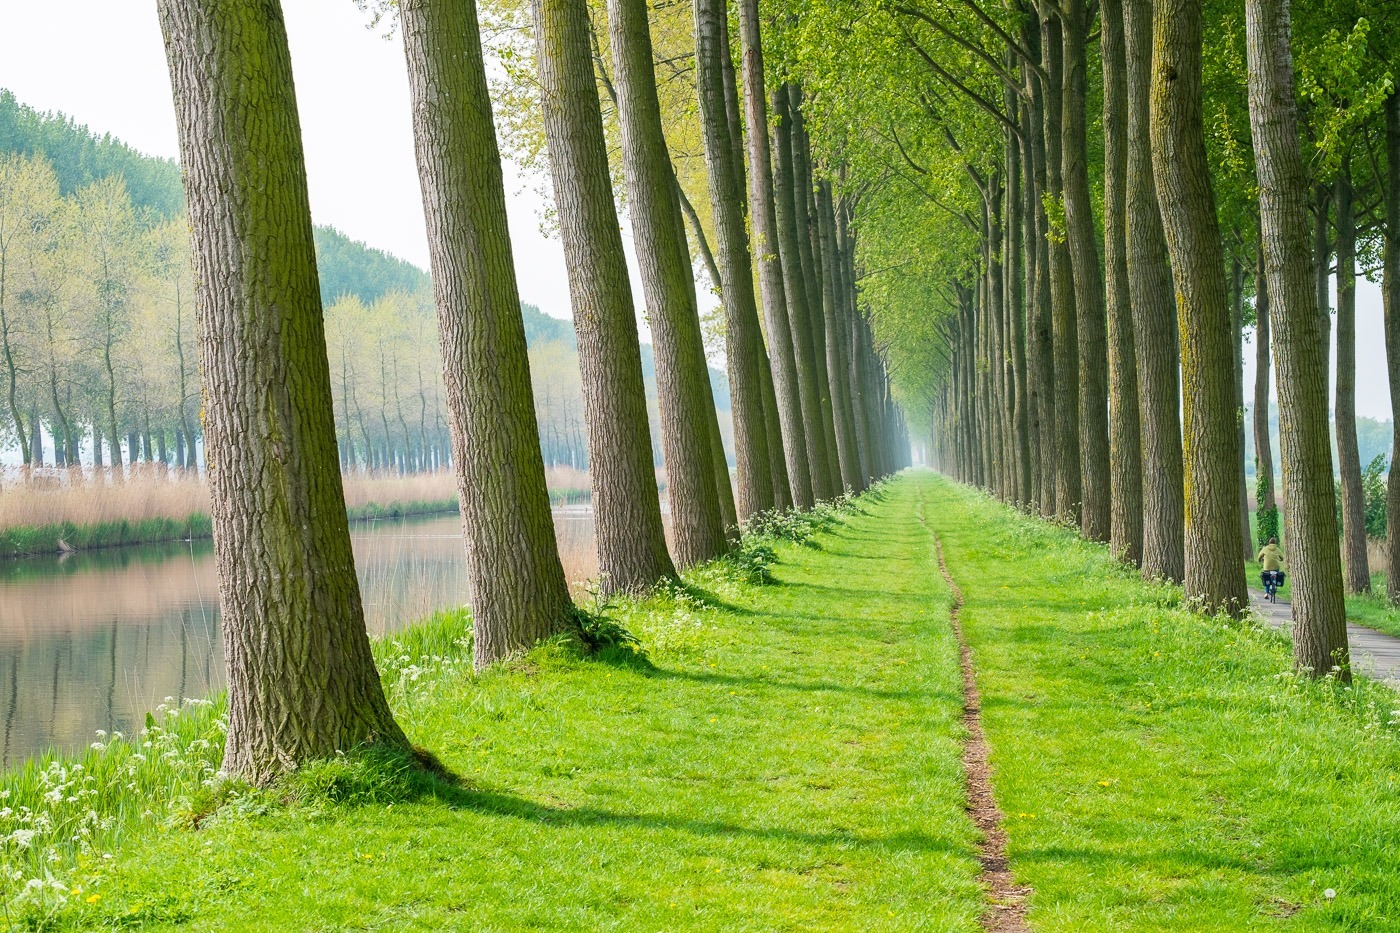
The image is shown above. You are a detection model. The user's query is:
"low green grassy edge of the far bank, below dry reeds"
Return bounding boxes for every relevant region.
[0,489,589,560]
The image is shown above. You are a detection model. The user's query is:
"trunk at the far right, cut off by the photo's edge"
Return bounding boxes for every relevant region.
[1380,91,1400,605]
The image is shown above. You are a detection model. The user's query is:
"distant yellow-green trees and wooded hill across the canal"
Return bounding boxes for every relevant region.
[0,100,728,476]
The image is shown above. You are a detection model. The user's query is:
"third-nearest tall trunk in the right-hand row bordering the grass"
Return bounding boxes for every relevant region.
[1123,0,1186,583]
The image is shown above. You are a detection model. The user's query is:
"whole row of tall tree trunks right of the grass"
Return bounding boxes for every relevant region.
[934,0,1372,677]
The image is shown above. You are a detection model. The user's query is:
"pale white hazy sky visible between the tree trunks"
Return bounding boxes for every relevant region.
[0,0,1390,419]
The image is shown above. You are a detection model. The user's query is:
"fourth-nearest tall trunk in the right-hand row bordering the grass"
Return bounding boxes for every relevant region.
[1102,0,1142,566]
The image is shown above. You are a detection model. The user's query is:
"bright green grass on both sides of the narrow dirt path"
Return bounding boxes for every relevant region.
[10,472,1400,932]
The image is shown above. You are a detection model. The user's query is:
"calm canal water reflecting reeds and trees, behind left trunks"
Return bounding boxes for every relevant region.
[0,509,596,768]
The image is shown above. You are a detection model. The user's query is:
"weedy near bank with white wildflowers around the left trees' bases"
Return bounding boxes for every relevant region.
[0,483,885,920]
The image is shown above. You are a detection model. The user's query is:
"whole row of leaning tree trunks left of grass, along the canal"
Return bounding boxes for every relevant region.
[160,0,907,782]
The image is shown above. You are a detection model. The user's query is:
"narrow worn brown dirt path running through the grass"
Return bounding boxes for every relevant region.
[920,526,1030,933]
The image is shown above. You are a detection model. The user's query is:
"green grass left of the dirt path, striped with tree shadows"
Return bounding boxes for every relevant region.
[7,482,981,930]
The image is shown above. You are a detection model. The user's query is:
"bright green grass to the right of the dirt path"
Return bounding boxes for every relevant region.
[929,478,1400,932]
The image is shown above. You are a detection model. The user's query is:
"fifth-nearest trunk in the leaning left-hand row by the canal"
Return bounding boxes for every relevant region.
[694,0,777,521]
